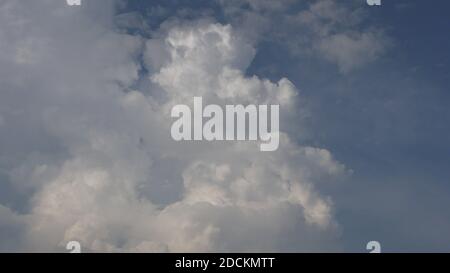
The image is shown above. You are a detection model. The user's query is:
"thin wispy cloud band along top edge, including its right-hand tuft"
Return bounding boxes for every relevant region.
[220,0,391,73]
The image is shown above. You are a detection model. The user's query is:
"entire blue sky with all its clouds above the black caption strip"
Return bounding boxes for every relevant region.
[0,0,450,252]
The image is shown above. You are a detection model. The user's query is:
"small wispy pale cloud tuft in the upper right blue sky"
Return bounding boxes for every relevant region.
[290,0,389,73]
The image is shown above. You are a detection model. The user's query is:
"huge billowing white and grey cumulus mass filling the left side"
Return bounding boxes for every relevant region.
[0,0,345,251]
